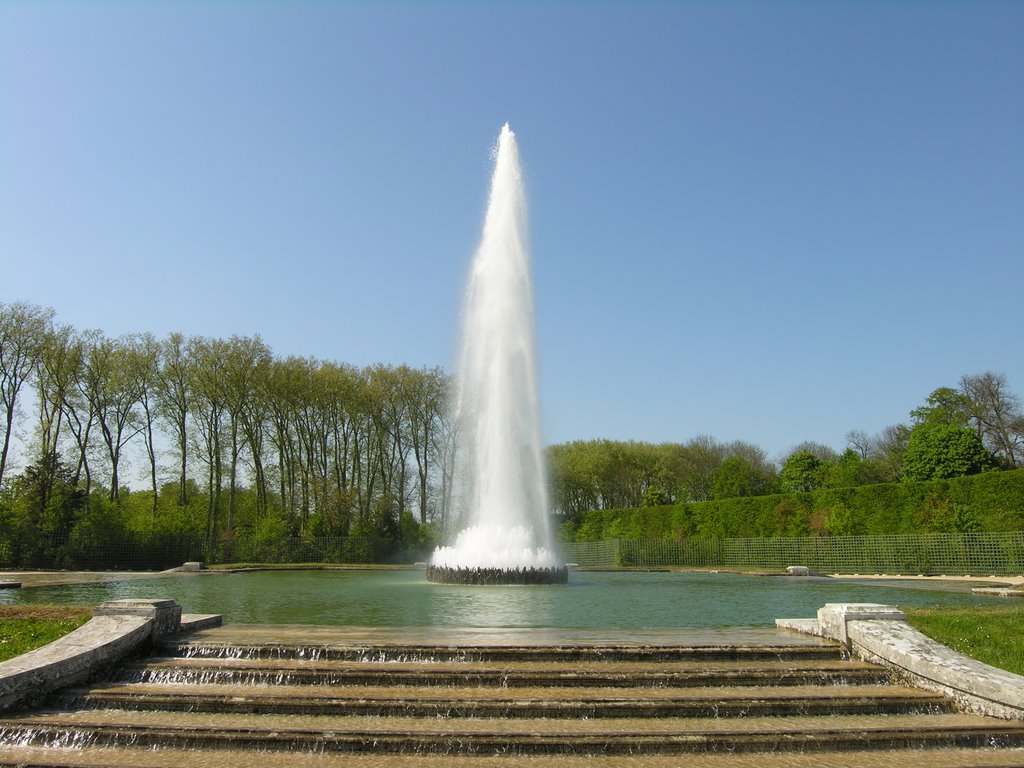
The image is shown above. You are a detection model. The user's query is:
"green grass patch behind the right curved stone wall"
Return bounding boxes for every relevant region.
[905,602,1024,675]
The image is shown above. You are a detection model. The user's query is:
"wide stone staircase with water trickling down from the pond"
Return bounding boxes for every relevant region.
[0,630,1024,768]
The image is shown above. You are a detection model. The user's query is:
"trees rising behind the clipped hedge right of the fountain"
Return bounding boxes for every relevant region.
[549,372,1024,517]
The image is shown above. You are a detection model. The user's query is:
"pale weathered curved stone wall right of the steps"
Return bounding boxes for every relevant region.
[775,603,1024,720]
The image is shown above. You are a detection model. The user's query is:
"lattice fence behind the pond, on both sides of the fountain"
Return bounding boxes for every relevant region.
[6,530,1024,575]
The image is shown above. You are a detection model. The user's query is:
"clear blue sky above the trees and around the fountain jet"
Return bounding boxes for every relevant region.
[0,0,1024,457]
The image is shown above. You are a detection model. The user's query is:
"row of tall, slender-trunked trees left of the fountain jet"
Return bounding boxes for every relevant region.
[0,303,454,542]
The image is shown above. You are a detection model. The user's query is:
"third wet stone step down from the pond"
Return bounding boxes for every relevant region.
[51,683,950,718]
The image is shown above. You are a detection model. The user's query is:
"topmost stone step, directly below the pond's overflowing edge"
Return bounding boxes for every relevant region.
[161,640,844,664]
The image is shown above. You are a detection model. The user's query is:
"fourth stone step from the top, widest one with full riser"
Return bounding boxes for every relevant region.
[0,713,1024,755]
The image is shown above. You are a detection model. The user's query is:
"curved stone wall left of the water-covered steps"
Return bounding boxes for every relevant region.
[0,599,221,712]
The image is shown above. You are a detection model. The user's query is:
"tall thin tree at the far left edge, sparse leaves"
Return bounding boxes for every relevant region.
[0,302,53,482]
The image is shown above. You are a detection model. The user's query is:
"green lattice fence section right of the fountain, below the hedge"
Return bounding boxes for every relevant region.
[559,530,1024,575]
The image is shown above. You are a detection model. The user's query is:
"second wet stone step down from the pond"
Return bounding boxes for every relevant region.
[114,657,889,688]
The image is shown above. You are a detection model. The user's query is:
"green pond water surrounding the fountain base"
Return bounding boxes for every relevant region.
[0,570,1000,629]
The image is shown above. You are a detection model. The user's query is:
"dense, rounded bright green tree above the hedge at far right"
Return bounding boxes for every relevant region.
[903,423,995,480]
